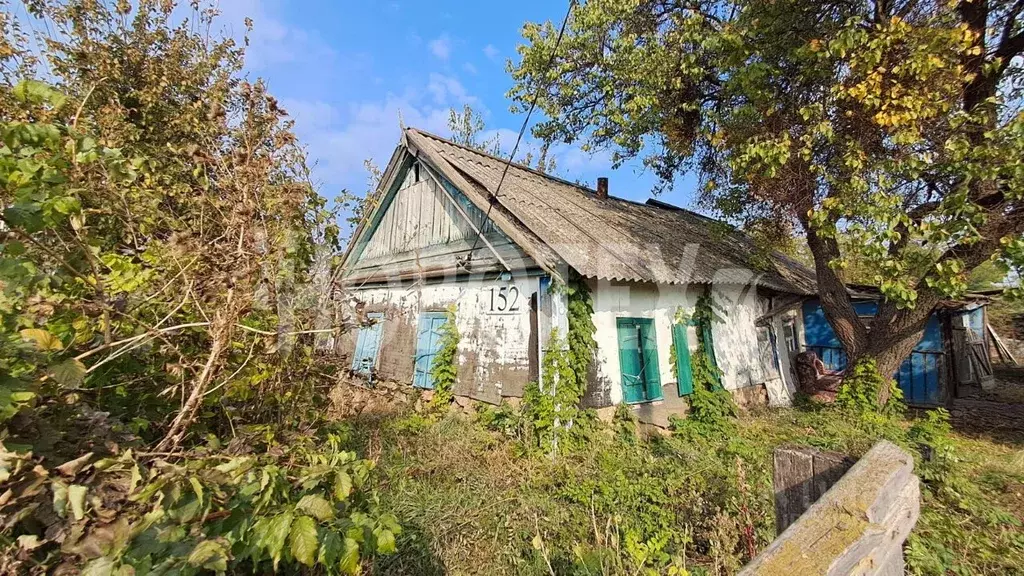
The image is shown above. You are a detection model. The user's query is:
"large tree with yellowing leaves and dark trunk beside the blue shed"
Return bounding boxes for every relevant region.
[510,0,1024,399]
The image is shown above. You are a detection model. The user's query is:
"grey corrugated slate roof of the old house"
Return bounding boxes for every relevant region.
[406,128,817,294]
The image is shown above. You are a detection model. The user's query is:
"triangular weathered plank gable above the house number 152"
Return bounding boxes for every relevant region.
[347,164,537,281]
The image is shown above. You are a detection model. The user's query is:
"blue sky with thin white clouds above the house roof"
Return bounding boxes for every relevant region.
[212,0,691,222]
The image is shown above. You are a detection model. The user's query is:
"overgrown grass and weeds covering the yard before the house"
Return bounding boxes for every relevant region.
[337,407,1024,575]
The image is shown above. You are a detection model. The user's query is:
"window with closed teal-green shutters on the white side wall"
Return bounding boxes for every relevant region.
[615,318,663,404]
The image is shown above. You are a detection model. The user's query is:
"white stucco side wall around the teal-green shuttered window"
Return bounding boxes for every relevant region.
[592,281,778,404]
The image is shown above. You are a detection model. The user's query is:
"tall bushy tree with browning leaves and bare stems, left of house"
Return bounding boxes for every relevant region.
[0,0,338,450]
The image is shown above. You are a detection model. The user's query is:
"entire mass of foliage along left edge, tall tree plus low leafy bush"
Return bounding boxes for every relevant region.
[0,0,387,575]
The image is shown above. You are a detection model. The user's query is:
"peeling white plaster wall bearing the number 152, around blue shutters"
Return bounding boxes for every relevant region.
[349,275,539,403]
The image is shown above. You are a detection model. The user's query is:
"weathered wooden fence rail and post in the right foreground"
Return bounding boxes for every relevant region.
[740,441,921,576]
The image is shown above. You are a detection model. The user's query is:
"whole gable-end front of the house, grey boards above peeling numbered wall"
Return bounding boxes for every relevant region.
[336,132,566,403]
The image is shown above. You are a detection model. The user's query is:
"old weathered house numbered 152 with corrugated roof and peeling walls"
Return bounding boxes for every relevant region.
[337,128,815,423]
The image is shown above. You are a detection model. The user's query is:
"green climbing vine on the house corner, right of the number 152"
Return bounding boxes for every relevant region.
[523,273,597,453]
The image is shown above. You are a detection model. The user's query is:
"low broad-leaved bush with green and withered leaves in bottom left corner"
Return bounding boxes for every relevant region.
[0,434,401,574]
